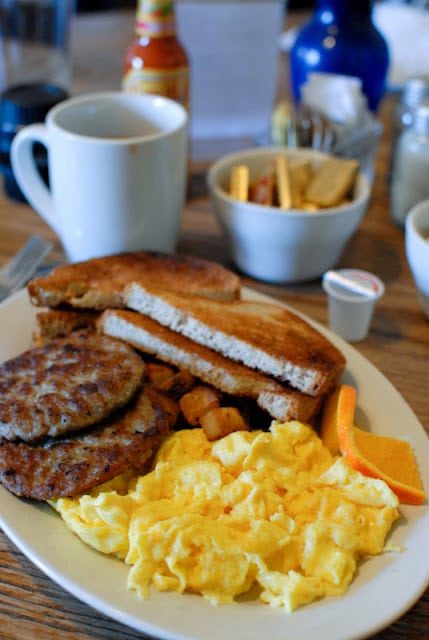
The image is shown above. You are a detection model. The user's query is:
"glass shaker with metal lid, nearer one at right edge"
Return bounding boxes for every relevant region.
[390,102,429,227]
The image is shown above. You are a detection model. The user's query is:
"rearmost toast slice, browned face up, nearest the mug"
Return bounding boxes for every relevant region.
[28,251,240,310]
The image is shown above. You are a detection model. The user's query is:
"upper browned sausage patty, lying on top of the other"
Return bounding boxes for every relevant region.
[0,331,144,442]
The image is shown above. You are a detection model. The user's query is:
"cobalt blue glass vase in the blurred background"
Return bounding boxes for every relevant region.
[290,0,389,111]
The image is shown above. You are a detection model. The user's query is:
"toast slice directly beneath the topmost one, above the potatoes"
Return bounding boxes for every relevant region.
[97,310,322,422]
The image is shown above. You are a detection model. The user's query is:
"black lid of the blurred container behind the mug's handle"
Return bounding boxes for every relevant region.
[0,83,68,133]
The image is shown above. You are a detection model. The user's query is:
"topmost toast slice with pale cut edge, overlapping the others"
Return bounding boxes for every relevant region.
[124,282,346,396]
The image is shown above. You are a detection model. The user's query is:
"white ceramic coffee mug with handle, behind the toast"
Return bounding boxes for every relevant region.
[11,92,188,262]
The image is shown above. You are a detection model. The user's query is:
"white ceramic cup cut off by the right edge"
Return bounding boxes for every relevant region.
[405,200,429,319]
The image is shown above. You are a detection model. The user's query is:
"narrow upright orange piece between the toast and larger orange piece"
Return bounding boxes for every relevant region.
[320,384,357,456]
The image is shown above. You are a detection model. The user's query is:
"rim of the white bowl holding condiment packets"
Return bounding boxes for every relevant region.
[206,145,370,218]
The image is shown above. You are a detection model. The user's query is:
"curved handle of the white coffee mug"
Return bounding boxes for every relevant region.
[10,124,60,234]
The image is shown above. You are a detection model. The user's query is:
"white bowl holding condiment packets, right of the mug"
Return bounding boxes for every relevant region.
[207,147,370,284]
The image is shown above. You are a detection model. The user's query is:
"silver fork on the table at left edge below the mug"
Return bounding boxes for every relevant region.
[0,236,53,301]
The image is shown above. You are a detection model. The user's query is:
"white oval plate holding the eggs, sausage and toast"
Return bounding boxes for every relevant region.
[0,290,429,640]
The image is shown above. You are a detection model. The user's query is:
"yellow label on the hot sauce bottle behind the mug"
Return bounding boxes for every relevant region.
[122,67,189,109]
